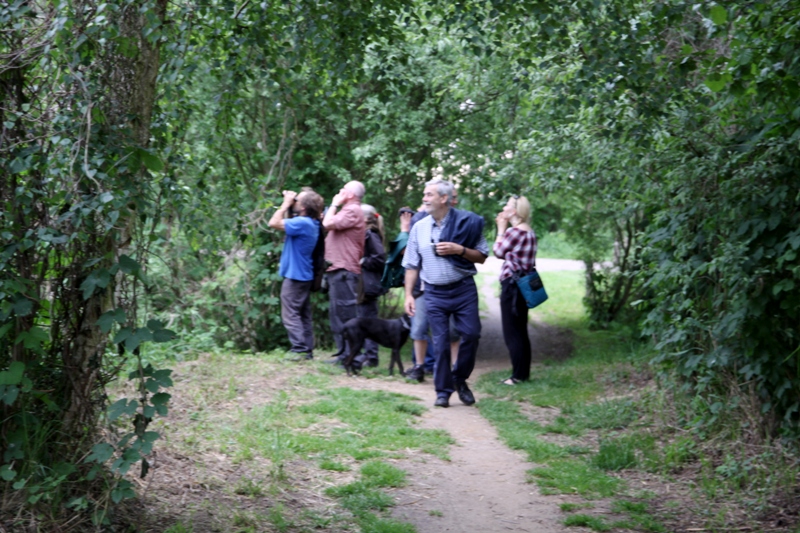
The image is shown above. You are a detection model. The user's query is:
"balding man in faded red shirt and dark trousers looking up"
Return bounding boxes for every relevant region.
[322,181,367,357]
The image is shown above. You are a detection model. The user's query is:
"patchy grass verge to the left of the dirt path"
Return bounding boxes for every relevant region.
[124,352,453,533]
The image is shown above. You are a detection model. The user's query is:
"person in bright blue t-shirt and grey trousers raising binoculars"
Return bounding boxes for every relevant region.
[268,187,323,361]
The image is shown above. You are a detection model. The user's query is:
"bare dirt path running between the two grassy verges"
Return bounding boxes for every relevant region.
[334,261,577,533]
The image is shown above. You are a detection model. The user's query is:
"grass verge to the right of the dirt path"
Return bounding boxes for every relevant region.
[477,272,800,532]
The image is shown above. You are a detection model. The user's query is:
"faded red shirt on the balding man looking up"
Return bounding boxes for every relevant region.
[325,202,367,274]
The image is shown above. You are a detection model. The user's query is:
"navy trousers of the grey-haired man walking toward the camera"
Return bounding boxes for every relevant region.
[425,276,481,396]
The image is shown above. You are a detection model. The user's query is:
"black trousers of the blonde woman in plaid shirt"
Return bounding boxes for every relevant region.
[500,278,531,381]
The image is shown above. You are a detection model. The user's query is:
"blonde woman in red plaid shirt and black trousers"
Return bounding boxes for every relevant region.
[493,194,536,385]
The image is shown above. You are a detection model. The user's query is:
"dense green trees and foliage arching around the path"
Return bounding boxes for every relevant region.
[0,0,800,521]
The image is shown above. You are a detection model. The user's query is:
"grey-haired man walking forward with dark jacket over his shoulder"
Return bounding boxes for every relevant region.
[403,179,489,407]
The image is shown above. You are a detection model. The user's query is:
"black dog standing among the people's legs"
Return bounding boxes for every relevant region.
[342,315,411,376]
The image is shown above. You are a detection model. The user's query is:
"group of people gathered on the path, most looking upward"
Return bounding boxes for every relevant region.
[269,179,536,407]
